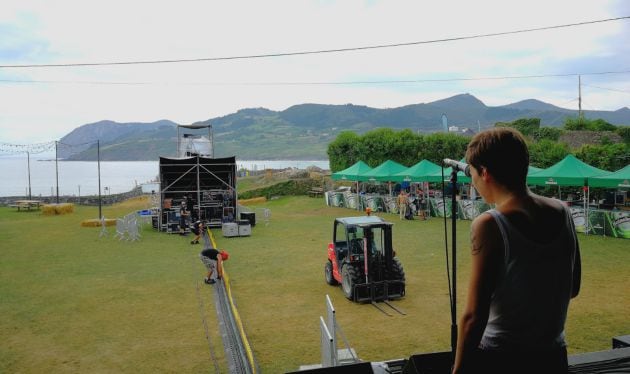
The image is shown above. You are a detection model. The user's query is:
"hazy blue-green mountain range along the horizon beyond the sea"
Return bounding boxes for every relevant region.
[59,94,630,161]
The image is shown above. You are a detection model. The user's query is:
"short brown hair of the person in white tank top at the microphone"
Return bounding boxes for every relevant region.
[466,127,529,190]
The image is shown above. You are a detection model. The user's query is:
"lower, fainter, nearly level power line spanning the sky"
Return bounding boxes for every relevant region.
[0,70,630,86]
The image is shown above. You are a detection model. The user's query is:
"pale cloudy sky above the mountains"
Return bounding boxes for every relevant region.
[0,0,630,144]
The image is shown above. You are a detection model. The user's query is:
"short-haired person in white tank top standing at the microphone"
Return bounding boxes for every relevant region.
[453,127,581,373]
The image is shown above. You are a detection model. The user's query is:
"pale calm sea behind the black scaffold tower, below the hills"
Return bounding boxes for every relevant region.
[0,156,330,198]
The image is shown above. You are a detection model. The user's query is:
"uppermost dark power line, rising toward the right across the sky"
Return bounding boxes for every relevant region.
[0,16,630,68]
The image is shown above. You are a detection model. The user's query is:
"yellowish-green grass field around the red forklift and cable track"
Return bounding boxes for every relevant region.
[0,197,630,373]
